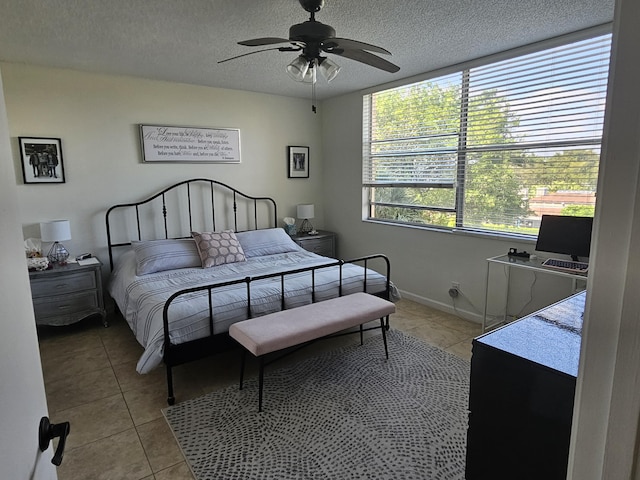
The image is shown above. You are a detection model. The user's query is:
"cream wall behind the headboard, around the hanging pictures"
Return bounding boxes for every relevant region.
[0,63,323,272]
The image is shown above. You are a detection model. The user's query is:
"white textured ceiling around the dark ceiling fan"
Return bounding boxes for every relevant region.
[0,0,614,99]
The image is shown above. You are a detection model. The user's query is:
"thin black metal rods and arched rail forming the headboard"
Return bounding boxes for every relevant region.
[105,178,278,270]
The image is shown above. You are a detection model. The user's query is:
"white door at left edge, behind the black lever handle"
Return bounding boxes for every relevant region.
[0,64,56,480]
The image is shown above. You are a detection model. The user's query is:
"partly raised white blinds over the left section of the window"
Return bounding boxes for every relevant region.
[363,73,462,186]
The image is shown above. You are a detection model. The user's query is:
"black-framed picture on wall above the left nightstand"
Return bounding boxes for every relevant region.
[18,137,65,183]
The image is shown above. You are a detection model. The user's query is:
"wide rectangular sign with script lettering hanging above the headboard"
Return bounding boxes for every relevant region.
[140,125,240,163]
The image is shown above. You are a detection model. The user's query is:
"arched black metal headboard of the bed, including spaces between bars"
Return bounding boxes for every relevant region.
[105,178,278,270]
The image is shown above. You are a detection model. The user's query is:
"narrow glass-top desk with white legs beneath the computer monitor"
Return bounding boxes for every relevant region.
[482,255,587,333]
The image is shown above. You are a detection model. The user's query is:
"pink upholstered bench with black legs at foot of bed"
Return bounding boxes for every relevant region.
[229,292,396,412]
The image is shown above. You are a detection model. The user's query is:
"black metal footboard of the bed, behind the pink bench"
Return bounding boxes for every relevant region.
[162,254,391,405]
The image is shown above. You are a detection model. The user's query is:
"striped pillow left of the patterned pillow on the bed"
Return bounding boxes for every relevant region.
[131,238,202,275]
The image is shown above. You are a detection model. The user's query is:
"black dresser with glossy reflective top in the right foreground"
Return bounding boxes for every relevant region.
[466,292,585,480]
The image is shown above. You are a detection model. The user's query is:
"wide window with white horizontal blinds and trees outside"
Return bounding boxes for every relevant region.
[363,34,611,235]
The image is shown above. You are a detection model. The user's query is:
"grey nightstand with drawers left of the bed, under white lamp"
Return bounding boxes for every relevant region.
[29,262,108,327]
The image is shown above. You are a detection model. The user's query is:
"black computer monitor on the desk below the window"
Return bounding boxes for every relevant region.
[536,215,593,261]
